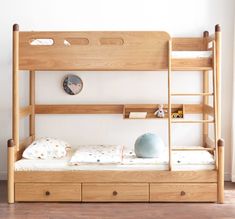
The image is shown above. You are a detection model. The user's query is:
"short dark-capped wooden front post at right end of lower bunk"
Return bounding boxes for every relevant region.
[217,139,224,204]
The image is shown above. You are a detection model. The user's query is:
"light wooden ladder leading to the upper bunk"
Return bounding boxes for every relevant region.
[168,40,218,170]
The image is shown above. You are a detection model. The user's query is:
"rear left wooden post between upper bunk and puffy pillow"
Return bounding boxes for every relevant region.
[29,71,35,141]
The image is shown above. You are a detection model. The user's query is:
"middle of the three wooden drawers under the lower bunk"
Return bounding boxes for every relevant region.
[82,183,149,202]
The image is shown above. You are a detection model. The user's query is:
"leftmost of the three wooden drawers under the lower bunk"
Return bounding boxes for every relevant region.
[15,183,81,202]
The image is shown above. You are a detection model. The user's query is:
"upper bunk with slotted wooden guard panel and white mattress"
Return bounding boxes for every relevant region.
[13,25,218,71]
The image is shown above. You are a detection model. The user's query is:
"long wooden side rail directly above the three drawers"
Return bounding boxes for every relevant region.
[15,170,217,183]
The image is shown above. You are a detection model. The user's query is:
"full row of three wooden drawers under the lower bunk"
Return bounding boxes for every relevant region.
[15,183,217,202]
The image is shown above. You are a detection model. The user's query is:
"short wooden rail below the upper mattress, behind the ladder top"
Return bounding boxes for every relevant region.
[172,58,212,71]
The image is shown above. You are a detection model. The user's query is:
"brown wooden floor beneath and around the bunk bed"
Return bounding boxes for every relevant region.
[0,181,235,219]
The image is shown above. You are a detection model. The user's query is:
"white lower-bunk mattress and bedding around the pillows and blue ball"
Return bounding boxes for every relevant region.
[15,148,215,171]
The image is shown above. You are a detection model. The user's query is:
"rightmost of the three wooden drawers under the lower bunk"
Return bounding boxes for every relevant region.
[150,183,217,202]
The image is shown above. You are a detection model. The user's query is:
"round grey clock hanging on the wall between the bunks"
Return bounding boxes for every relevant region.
[63,75,83,95]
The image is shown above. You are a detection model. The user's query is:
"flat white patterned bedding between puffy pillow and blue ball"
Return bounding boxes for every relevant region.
[69,145,123,165]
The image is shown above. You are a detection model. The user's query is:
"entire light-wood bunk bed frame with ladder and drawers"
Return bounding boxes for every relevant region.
[8,24,224,203]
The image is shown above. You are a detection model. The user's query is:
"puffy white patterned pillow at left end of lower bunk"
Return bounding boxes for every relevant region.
[22,138,71,160]
